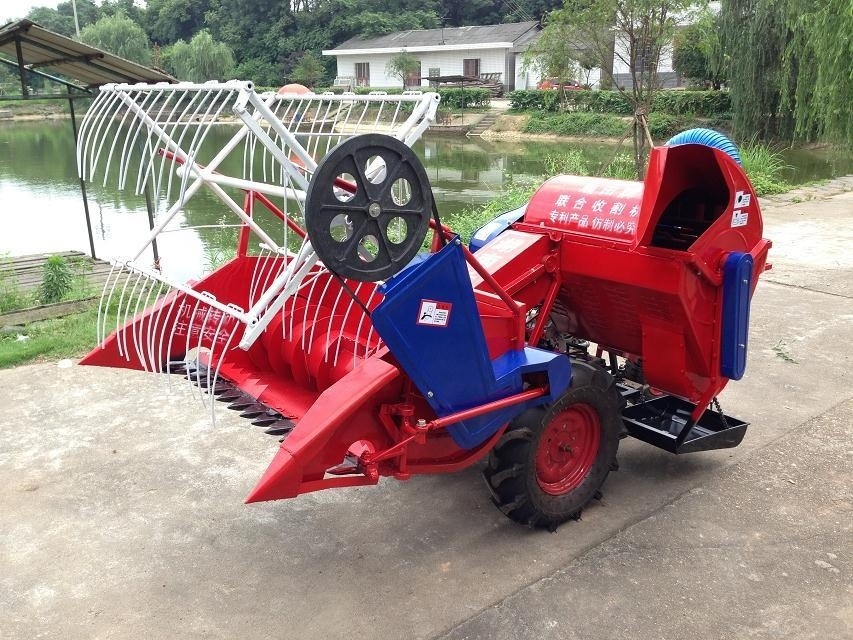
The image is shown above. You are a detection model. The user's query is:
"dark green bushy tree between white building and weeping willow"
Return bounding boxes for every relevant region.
[672,10,726,89]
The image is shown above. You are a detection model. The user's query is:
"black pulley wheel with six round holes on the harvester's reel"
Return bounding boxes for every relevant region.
[305,133,433,282]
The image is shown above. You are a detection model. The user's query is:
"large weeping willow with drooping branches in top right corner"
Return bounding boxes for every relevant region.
[722,0,853,145]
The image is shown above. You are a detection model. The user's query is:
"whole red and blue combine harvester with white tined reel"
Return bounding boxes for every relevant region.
[79,83,770,528]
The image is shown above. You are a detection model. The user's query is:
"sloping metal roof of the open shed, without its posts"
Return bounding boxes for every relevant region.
[0,20,176,88]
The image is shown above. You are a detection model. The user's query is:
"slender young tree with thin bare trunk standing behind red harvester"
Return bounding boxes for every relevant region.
[528,0,705,178]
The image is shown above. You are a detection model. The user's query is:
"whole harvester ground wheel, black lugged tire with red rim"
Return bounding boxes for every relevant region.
[483,360,624,531]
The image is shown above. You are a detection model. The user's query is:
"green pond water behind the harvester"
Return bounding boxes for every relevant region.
[0,120,853,277]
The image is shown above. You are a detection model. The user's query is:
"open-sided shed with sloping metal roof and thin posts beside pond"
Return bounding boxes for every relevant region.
[0,20,177,258]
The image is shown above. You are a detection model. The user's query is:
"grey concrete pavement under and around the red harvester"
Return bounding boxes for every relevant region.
[0,182,853,639]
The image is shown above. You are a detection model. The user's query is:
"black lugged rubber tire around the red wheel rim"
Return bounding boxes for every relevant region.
[483,360,624,531]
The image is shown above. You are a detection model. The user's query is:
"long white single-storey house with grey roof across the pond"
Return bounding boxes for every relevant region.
[323,21,539,91]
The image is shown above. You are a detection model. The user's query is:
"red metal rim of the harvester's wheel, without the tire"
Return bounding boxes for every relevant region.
[536,404,601,496]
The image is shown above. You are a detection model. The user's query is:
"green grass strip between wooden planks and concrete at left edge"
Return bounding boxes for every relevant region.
[0,301,103,369]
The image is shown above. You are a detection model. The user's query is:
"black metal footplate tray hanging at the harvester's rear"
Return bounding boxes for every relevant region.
[622,396,749,453]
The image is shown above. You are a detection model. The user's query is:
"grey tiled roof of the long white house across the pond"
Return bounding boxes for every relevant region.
[332,21,539,52]
